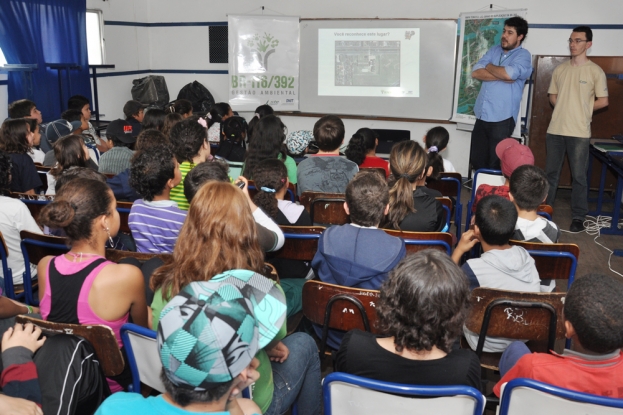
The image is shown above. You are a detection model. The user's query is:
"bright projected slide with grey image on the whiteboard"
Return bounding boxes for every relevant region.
[318,28,420,98]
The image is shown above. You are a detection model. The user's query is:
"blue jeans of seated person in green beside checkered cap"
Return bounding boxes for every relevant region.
[264,333,322,415]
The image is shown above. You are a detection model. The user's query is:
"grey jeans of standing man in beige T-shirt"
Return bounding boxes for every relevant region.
[545,134,590,221]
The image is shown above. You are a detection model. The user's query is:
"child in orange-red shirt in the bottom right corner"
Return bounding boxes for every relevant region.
[493,274,623,399]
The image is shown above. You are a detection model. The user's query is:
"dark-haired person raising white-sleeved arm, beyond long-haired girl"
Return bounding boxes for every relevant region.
[184,160,285,252]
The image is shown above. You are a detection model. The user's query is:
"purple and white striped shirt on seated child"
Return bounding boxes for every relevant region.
[128,199,186,253]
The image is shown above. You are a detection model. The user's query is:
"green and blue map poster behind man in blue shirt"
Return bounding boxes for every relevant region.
[450,9,528,127]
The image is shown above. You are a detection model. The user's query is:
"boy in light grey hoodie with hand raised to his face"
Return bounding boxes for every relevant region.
[452,195,555,352]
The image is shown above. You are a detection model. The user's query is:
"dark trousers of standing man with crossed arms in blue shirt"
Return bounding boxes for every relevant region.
[469,117,515,170]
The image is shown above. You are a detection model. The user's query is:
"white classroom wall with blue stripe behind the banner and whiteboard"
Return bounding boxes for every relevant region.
[0,0,623,175]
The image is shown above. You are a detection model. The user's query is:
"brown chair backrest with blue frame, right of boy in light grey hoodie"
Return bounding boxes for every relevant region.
[510,241,580,287]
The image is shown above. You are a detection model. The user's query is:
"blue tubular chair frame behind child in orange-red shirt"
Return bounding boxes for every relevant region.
[500,378,623,415]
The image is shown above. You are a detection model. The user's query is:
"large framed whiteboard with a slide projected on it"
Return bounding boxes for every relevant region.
[299,19,457,120]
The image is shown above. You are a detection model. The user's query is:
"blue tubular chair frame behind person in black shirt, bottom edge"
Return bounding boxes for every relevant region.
[322,372,485,415]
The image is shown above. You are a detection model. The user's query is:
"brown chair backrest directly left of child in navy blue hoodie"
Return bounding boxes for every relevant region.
[268,226,327,261]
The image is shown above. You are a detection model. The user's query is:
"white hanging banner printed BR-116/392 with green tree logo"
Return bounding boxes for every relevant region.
[228,15,300,111]
